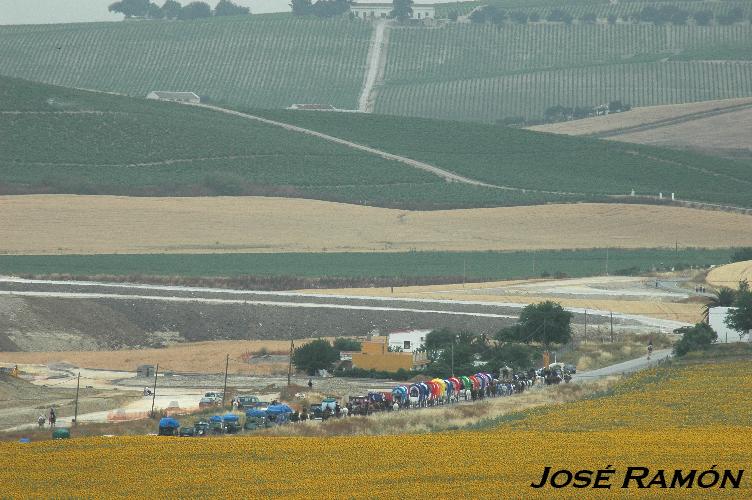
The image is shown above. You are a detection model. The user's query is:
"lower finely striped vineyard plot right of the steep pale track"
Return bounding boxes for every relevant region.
[376,61,752,123]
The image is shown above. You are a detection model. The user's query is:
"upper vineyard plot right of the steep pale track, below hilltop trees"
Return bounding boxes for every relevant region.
[385,24,752,83]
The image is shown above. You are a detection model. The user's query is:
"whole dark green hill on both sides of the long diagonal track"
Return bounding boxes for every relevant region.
[0,74,752,209]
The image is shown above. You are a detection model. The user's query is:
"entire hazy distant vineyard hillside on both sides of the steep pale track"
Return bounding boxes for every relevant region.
[0,14,752,123]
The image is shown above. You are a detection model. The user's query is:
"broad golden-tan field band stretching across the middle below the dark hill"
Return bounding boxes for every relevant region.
[0,195,752,254]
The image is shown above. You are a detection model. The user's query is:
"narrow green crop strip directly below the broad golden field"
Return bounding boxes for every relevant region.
[0,248,733,280]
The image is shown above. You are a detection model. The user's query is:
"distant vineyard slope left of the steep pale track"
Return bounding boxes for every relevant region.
[0,16,371,109]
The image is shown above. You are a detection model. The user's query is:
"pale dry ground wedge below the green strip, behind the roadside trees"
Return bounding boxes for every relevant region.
[301,276,702,323]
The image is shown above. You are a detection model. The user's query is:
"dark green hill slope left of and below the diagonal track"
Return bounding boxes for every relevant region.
[0,74,567,209]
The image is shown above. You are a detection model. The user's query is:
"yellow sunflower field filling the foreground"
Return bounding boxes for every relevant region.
[0,363,752,498]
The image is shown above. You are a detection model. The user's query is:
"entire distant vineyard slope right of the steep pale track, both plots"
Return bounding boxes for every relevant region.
[376,23,752,122]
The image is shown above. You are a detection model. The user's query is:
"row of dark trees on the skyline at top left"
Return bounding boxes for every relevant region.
[108,0,250,19]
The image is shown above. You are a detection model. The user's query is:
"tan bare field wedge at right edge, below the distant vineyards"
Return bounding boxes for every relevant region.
[530,98,752,157]
